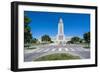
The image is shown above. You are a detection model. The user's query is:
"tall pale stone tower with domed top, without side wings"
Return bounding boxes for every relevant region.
[57,18,65,44]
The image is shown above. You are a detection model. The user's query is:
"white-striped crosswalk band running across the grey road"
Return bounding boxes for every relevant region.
[35,48,89,53]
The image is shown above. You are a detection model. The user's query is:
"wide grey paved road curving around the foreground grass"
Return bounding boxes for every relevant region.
[24,45,90,62]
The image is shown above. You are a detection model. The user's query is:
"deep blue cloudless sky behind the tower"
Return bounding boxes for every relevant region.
[24,11,90,38]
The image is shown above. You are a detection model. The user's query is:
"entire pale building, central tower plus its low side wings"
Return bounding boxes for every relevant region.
[38,18,72,44]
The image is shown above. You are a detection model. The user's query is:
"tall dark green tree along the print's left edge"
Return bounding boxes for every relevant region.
[24,16,32,43]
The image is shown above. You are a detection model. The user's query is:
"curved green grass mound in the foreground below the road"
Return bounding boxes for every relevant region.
[35,53,80,61]
